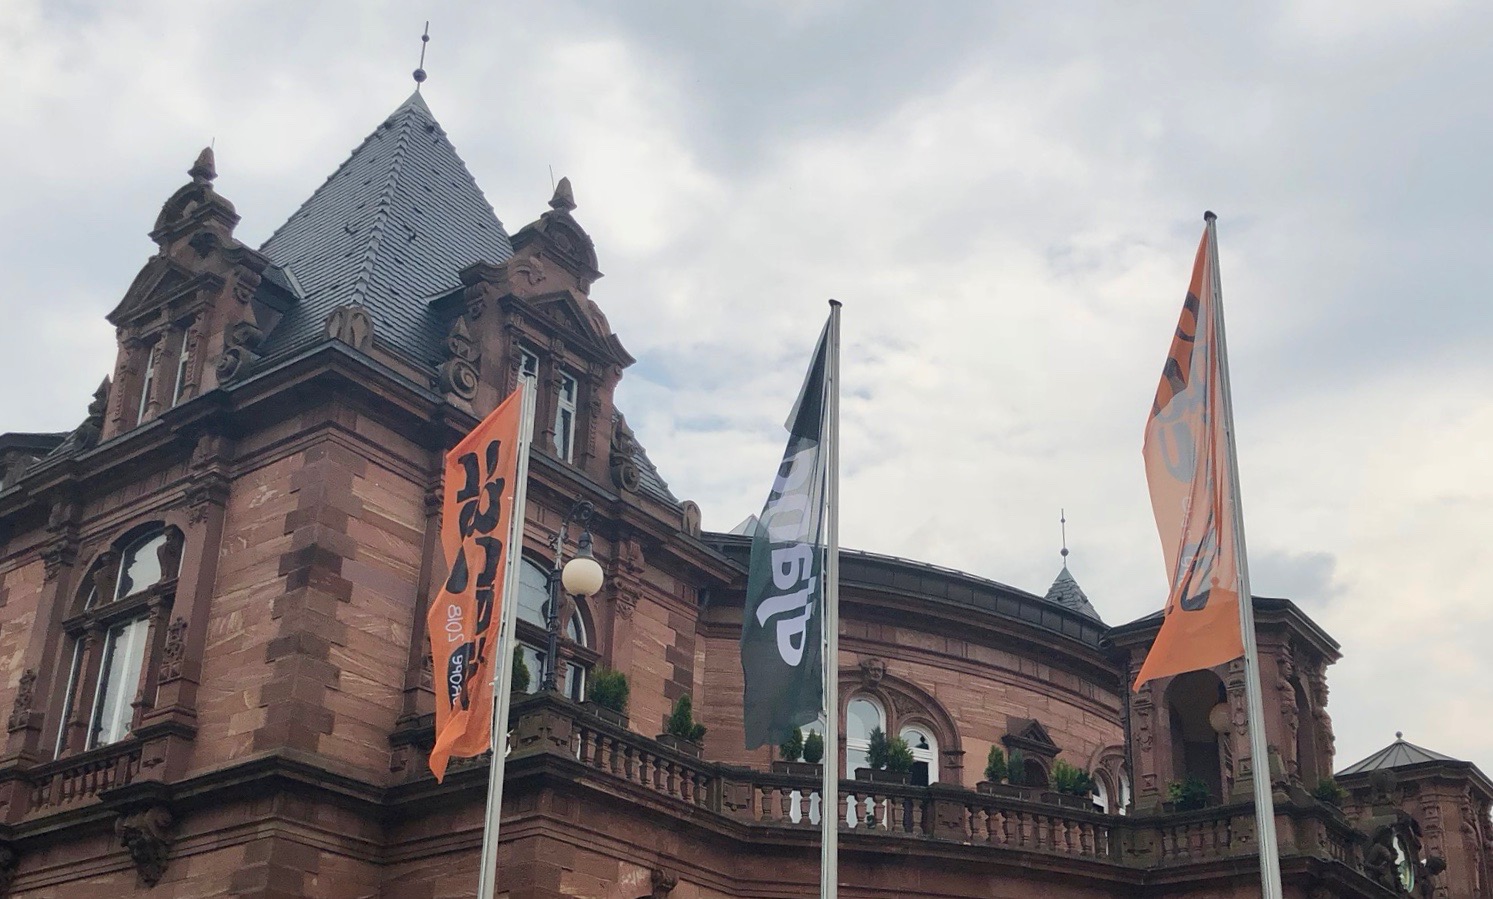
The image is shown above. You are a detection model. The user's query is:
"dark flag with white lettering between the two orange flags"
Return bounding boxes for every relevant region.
[742,324,829,750]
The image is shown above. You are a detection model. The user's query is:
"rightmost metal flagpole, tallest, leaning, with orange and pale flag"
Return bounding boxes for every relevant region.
[1203,212,1281,899]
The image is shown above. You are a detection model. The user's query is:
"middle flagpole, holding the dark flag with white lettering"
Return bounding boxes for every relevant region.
[820,300,841,899]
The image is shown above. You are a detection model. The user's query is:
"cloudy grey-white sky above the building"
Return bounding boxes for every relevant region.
[0,0,1493,772]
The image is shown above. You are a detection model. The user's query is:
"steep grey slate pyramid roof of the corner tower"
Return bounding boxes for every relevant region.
[261,93,514,361]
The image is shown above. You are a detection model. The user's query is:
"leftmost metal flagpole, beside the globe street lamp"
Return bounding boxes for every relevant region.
[476,375,534,899]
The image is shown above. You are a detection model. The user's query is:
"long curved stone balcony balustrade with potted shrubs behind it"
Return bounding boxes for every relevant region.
[495,696,1362,872]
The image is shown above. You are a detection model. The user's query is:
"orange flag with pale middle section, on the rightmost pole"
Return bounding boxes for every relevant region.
[1135,222,1244,688]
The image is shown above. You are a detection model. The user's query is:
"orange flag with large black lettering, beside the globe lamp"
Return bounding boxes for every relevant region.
[426,390,523,781]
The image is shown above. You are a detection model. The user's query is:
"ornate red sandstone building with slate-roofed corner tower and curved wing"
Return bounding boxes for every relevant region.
[0,87,1493,899]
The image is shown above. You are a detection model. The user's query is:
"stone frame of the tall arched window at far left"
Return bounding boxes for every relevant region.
[52,520,185,759]
